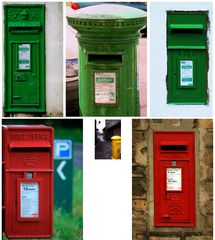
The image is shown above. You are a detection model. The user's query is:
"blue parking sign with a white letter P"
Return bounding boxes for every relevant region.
[54,139,72,160]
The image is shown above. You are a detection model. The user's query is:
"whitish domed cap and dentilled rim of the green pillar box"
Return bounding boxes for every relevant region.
[67,4,147,38]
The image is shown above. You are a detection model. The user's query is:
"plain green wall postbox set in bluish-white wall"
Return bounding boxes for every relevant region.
[167,11,208,104]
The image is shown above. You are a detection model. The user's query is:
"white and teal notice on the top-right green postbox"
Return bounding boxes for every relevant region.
[180,60,193,87]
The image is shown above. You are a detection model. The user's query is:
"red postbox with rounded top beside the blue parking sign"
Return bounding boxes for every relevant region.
[3,125,54,238]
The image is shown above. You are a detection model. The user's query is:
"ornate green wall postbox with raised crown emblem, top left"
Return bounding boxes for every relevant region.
[4,4,45,113]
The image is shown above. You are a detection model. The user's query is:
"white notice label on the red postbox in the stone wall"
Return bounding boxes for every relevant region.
[166,168,181,191]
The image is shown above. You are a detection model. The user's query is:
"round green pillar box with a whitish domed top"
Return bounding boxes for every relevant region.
[68,4,146,116]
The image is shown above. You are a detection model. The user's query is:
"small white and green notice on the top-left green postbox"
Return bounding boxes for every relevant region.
[19,44,31,69]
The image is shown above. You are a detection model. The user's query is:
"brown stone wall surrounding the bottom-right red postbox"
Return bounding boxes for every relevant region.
[132,119,213,240]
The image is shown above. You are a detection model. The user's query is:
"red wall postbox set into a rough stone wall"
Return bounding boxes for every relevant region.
[154,131,195,227]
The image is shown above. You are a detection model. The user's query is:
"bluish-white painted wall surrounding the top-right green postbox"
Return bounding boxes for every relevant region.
[149,2,213,117]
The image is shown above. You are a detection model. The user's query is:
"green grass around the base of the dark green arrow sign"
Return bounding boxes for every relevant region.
[3,169,83,240]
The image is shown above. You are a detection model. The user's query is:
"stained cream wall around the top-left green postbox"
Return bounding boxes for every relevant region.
[2,2,63,117]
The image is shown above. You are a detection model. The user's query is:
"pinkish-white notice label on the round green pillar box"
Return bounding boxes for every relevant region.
[94,72,116,104]
